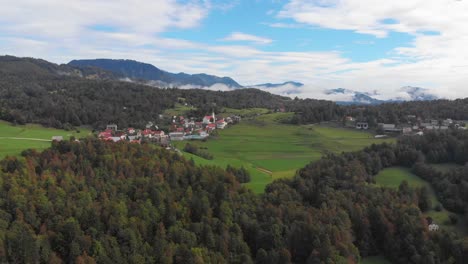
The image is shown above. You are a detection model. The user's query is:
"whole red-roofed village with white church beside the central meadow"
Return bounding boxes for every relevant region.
[97,112,241,147]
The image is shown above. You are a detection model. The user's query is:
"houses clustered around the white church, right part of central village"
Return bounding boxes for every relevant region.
[169,112,241,140]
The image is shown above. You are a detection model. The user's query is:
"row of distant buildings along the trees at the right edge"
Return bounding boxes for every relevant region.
[345,116,466,135]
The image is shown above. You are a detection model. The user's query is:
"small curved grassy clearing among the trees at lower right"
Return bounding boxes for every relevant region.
[375,167,467,234]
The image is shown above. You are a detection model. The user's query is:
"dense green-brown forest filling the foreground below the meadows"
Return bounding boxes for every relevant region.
[0,132,468,263]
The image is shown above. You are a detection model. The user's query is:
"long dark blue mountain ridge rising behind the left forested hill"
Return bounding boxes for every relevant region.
[68,59,242,88]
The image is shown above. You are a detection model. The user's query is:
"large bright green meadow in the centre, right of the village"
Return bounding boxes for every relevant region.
[176,113,394,193]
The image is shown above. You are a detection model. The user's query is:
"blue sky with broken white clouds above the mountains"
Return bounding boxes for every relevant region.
[0,0,468,99]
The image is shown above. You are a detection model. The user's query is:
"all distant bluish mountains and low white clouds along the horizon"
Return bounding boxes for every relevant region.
[68,59,438,104]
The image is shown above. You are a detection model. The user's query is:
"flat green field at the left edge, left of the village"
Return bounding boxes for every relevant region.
[0,121,90,158]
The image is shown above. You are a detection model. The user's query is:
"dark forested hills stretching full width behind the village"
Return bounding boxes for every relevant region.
[0,56,468,131]
